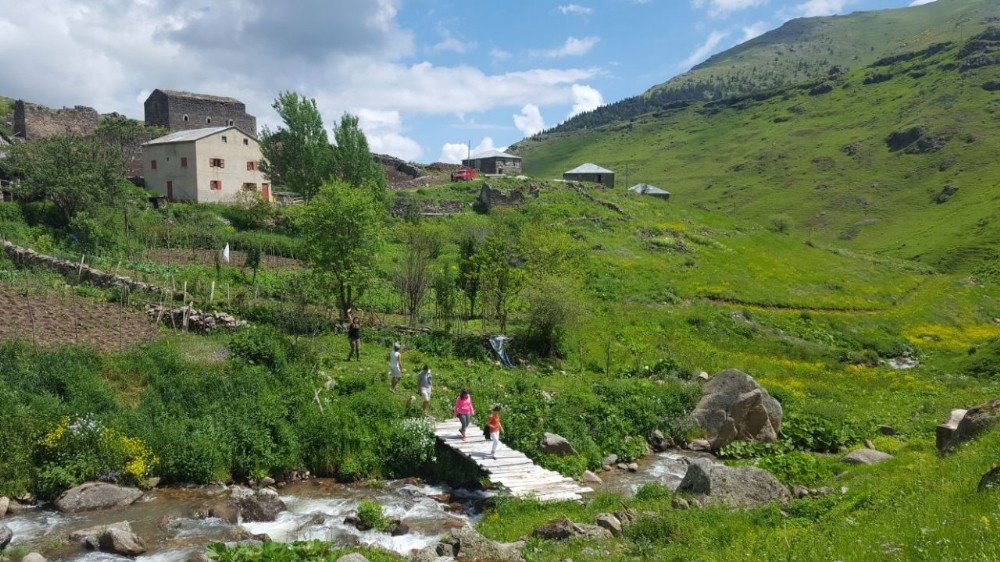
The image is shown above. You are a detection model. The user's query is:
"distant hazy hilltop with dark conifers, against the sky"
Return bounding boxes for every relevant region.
[553,0,1000,132]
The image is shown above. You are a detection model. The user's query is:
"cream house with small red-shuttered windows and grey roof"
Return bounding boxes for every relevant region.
[143,126,273,203]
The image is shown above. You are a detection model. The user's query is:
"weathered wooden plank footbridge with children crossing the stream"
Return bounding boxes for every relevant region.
[434,420,593,501]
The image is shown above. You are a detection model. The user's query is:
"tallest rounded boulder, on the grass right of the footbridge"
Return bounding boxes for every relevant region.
[691,369,782,450]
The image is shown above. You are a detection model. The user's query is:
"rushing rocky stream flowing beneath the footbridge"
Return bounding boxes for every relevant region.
[2,450,712,562]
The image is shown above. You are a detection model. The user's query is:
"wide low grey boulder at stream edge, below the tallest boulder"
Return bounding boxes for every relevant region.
[677,459,791,508]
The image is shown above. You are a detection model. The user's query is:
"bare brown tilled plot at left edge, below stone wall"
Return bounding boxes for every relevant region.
[0,284,159,351]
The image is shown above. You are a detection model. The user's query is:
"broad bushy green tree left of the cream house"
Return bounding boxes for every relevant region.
[2,135,136,224]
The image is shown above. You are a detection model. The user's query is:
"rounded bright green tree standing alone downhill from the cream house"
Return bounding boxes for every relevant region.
[298,182,385,321]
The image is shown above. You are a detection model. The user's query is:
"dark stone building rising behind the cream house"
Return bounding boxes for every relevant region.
[143,89,257,137]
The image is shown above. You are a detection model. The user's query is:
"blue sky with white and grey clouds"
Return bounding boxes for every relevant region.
[0,0,933,162]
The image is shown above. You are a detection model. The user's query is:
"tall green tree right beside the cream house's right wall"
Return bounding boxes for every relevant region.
[260,92,333,200]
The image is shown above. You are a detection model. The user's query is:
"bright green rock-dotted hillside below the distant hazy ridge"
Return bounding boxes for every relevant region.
[516,27,1000,274]
